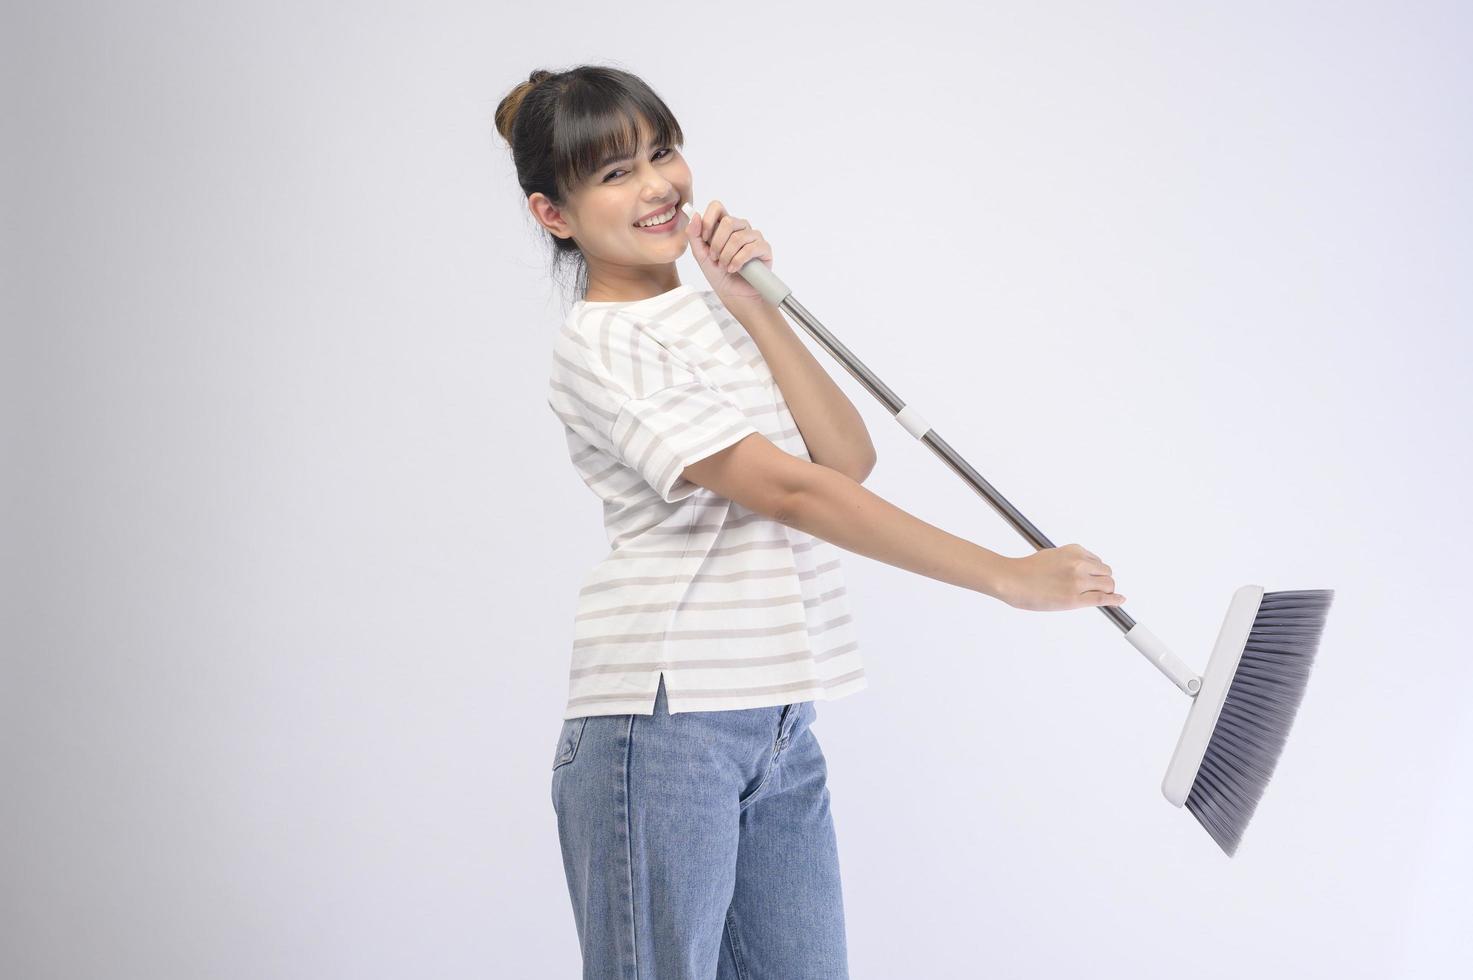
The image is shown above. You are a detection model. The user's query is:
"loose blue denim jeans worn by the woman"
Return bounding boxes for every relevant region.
[552,678,848,980]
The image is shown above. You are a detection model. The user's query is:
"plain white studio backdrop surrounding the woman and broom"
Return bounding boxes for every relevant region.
[0,0,1473,980]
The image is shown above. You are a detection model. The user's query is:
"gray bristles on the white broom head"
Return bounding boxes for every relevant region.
[1186,589,1335,858]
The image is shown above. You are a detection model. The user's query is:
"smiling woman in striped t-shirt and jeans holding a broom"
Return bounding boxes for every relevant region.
[496,66,1124,980]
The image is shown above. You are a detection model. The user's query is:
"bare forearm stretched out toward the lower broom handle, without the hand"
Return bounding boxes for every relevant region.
[778,466,1015,601]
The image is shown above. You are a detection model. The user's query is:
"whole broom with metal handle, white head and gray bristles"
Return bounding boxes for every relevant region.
[681,202,1335,856]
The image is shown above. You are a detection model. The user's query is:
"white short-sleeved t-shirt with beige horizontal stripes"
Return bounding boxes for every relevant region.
[548,278,868,719]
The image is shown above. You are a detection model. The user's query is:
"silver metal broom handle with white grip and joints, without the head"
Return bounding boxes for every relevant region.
[715,237,1202,696]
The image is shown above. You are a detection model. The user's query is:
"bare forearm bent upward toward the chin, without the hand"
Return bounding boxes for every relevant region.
[731,301,875,480]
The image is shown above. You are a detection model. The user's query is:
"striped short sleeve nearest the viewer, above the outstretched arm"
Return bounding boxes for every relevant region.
[549,311,759,503]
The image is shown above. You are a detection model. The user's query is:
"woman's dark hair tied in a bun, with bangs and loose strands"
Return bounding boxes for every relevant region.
[496,65,685,296]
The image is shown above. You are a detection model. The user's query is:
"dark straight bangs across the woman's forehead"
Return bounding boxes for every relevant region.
[552,78,685,195]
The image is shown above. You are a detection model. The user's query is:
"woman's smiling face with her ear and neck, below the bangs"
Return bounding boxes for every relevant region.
[527,118,691,302]
